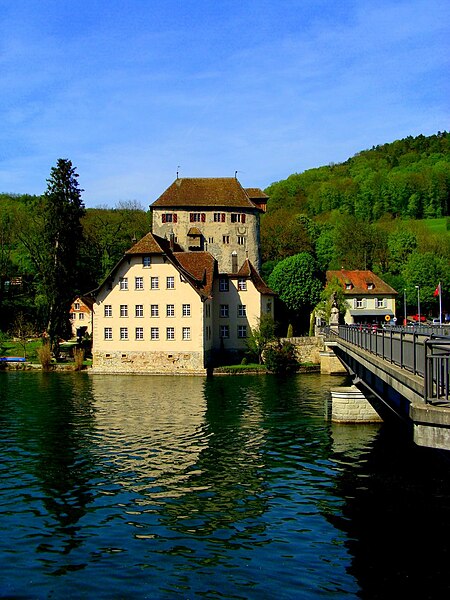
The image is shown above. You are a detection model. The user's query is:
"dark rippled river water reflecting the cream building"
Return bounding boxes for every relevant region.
[0,372,450,599]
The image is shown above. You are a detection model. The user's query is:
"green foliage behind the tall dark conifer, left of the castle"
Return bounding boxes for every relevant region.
[0,178,150,333]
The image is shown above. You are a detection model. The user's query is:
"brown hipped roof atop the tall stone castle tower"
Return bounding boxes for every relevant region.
[151,177,255,209]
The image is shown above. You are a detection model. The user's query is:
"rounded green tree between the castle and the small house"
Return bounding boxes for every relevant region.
[268,252,323,328]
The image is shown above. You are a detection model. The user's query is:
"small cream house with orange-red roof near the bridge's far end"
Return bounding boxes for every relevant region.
[326,269,398,324]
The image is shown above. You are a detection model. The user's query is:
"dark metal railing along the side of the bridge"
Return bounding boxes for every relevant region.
[325,325,450,403]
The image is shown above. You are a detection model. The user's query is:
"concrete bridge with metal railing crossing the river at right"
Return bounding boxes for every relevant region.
[325,325,450,450]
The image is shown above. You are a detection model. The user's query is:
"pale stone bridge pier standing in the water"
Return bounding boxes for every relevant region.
[330,385,383,423]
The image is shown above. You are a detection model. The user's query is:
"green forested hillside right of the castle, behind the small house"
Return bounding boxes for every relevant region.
[261,132,450,330]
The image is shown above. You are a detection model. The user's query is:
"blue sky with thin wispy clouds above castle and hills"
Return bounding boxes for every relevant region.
[0,0,450,207]
